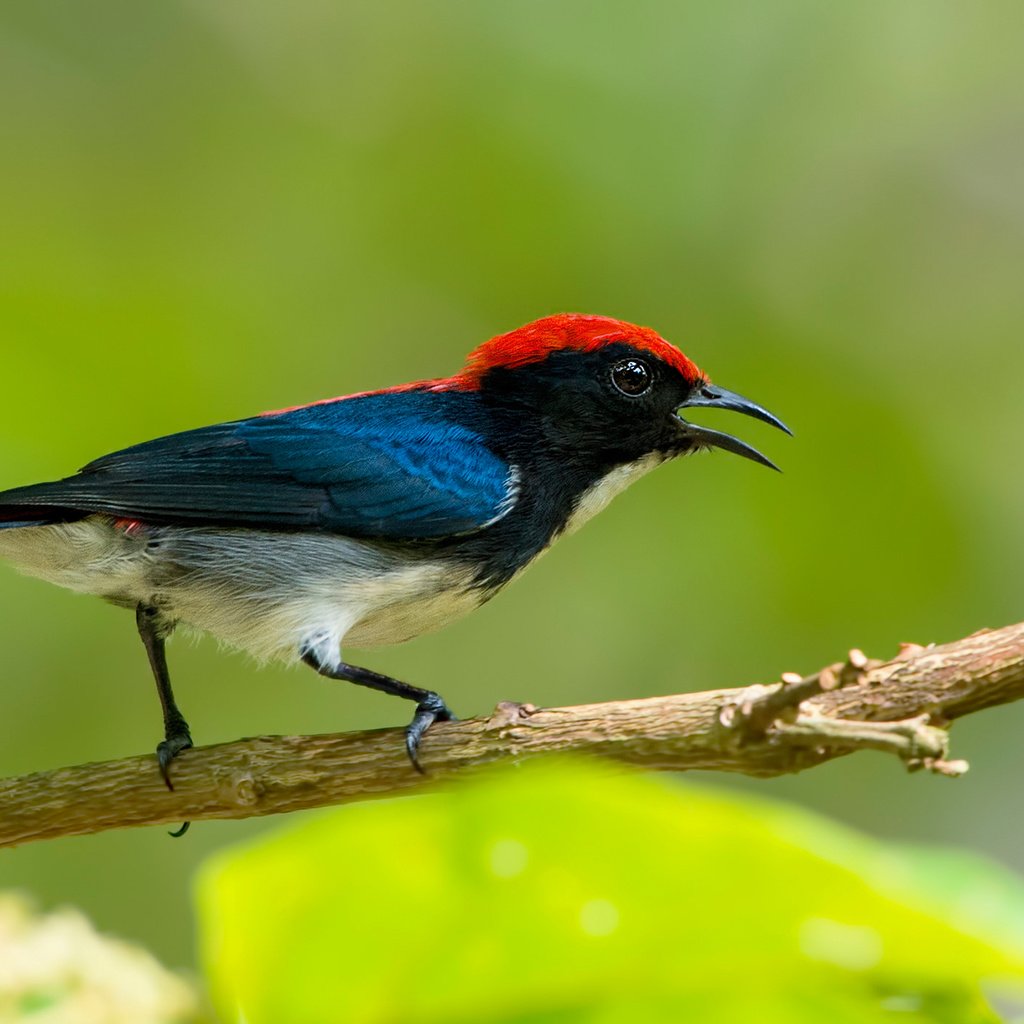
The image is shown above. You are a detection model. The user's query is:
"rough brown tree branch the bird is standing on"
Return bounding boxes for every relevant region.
[0,623,1024,847]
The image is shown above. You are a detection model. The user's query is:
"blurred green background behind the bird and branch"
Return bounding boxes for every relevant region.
[0,0,1024,964]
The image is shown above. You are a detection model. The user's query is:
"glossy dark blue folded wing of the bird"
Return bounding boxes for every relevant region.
[0,391,515,540]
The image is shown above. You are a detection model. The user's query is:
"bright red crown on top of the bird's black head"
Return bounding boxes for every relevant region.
[457,313,705,389]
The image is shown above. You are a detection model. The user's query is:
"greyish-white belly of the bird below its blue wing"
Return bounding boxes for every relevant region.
[0,516,494,664]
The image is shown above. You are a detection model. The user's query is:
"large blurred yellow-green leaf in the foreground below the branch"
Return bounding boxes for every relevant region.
[199,764,1024,1024]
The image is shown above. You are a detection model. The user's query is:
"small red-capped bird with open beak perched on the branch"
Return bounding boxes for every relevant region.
[0,313,792,788]
